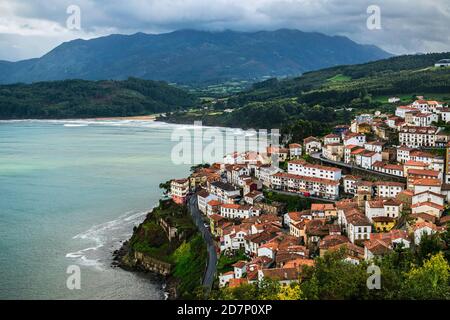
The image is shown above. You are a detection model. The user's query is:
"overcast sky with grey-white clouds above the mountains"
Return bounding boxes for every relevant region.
[0,0,450,61]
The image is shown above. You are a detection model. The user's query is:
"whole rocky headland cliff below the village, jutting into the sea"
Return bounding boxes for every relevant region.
[115,200,206,299]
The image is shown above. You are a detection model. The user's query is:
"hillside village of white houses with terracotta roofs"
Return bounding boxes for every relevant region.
[170,97,450,288]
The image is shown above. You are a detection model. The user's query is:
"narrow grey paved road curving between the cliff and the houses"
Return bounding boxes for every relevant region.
[188,195,217,291]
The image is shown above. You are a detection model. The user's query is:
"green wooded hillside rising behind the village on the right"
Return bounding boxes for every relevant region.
[162,53,450,141]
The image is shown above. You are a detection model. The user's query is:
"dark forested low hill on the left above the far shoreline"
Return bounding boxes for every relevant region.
[0,78,197,119]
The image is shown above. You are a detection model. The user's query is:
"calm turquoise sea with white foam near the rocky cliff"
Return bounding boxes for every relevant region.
[0,121,206,299]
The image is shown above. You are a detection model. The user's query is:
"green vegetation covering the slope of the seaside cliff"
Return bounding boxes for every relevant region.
[122,200,207,299]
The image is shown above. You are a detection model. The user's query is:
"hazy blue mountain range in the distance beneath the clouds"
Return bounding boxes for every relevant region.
[0,29,391,84]
